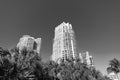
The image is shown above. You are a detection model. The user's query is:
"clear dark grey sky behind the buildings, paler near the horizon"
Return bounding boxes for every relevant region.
[0,0,120,74]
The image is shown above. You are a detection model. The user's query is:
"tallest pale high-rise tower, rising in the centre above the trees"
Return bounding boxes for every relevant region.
[51,22,77,62]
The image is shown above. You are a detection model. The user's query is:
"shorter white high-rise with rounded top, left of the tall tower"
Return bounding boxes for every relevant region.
[17,35,41,53]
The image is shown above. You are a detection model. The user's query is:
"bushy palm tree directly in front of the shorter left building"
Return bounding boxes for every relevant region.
[11,48,41,80]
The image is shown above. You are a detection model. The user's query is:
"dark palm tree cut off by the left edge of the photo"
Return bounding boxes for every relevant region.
[0,48,14,80]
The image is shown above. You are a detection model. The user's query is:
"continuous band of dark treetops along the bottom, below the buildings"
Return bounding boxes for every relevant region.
[0,48,109,80]
